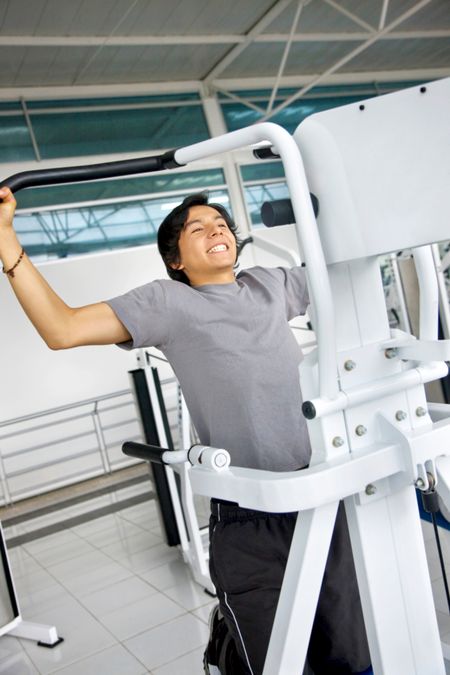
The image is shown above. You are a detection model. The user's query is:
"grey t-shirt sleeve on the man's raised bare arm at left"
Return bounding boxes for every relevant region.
[105,281,171,349]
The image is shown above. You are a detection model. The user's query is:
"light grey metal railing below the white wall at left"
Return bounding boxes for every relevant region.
[0,389,142,504]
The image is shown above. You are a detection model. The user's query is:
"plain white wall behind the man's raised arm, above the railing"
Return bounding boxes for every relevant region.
[0,245,165,421]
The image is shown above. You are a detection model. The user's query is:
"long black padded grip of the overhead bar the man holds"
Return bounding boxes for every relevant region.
[1,150,182,192]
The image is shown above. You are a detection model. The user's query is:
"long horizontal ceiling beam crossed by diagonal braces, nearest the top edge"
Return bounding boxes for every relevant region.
[0,29,450,48]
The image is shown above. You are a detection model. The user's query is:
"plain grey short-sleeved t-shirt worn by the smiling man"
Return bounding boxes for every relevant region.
[107,267,310,471]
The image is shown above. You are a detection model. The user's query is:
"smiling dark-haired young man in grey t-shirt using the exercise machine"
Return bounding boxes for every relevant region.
[0,190,370,675]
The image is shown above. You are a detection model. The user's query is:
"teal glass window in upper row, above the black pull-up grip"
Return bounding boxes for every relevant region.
[0,93,209,162]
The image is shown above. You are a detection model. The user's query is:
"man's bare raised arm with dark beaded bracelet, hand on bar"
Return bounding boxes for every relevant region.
[0,187,130,349]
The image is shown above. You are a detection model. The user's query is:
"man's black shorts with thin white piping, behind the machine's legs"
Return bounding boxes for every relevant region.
[210,500,370,675]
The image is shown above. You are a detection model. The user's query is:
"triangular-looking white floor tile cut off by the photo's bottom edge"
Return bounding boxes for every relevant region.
[49,645,148,675]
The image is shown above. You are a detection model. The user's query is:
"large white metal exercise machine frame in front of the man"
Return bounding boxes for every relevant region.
[156,79,450,675]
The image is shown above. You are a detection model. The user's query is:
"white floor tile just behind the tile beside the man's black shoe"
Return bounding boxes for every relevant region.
[99,592,184,642]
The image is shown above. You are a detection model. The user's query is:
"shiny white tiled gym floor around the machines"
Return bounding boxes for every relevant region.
[0,480,450,675]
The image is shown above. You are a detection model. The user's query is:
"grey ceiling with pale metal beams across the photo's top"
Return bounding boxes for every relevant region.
[0,0,450,99]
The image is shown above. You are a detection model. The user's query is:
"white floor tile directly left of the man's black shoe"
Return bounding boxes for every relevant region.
[125,614,208,670]
